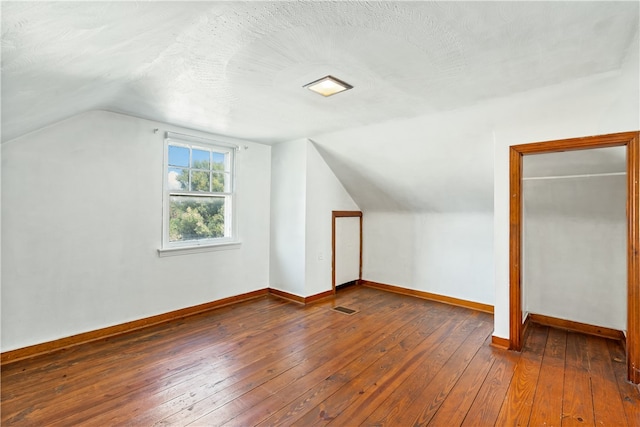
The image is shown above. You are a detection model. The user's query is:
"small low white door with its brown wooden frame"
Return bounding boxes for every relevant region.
[331,211,362,293]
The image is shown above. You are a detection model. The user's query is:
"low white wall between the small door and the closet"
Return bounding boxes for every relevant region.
[363,212,494,305]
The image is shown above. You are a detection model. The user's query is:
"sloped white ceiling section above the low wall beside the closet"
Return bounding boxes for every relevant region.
[312,108,493,212]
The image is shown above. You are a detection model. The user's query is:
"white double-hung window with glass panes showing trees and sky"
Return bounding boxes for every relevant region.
[163,137,235,249]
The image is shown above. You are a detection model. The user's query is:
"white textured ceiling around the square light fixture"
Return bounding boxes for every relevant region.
[1,2,638,143]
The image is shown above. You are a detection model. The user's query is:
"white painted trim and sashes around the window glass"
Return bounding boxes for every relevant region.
[158,131,241,249]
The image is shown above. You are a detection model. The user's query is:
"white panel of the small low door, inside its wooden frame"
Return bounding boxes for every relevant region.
[335,217,360,286]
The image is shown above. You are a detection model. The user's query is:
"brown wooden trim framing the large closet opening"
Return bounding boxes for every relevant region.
[509,132,640,384]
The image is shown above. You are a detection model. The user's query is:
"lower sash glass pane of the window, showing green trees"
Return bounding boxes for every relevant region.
[169,196,225,242]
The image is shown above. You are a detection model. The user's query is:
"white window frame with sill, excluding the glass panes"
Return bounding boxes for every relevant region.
[158,132,240,256]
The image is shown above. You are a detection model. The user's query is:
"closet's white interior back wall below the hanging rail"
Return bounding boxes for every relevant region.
[522,176,627,330]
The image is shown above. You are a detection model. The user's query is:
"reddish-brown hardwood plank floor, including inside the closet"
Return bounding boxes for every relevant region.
[1,286,640,426]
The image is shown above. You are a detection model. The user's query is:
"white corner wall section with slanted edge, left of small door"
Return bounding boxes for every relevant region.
[271,139,359,297]
